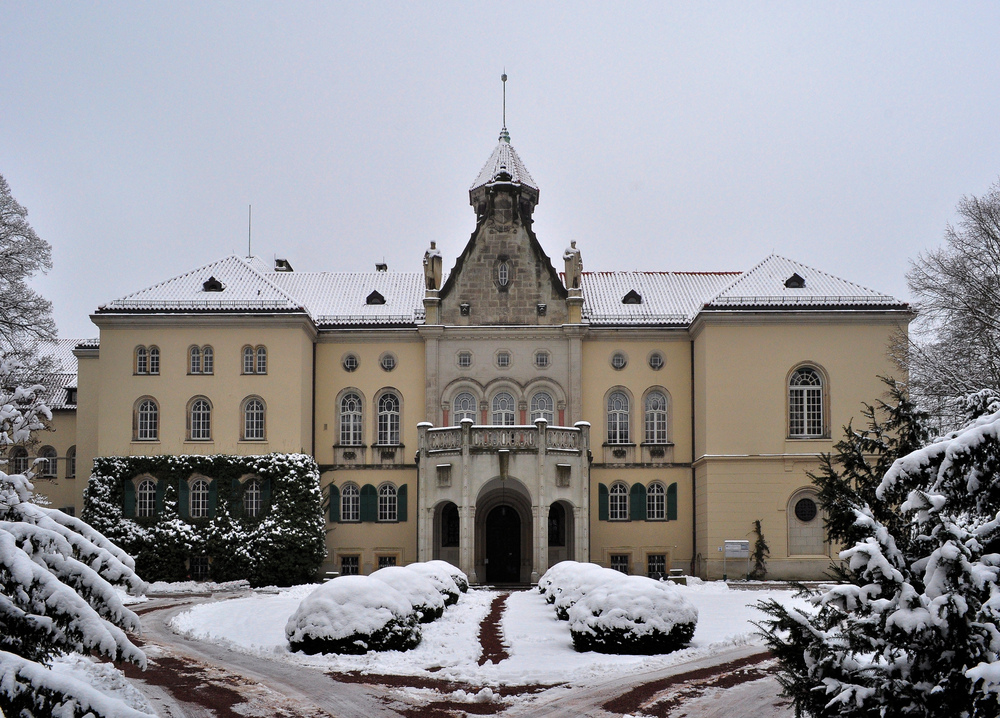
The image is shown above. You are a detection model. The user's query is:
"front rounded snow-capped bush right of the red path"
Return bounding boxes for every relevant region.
[569,571,698,655]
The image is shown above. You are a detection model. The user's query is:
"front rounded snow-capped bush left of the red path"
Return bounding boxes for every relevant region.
[285,576,420,654]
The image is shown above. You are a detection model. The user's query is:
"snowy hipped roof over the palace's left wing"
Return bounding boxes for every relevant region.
[97,255,302,312]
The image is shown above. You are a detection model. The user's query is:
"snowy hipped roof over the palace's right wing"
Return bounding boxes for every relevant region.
[706,254,906,309]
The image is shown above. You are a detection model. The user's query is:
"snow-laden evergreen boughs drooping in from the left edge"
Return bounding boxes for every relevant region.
[0,354,152,718]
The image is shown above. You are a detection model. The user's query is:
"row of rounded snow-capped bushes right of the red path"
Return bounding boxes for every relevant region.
[538,561,698,654]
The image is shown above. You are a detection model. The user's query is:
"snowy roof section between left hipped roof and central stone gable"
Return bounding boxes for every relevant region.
[268,272,424,325]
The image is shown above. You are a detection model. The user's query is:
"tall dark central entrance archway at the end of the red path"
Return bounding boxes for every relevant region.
[475,477,534,583]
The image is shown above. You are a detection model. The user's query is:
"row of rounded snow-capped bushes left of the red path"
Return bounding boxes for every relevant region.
[285,561,468,654]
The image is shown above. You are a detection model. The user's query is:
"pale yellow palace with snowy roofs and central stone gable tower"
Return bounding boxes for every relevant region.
[38,130,911,583]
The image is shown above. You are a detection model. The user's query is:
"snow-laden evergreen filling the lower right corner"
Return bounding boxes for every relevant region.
[759,413,1000,718]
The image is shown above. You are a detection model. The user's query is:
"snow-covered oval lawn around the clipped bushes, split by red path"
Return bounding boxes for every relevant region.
[172,581,805,685]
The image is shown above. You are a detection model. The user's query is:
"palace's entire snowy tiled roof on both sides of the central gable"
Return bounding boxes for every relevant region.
[99,255,907,332]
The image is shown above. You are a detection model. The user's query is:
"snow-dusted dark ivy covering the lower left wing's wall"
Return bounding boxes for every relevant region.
[82,454,326,586]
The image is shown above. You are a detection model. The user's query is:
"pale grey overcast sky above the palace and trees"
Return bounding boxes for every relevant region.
[0,0,1000,337]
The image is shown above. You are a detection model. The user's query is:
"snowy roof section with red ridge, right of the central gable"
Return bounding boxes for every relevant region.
[580,272,740,326]
